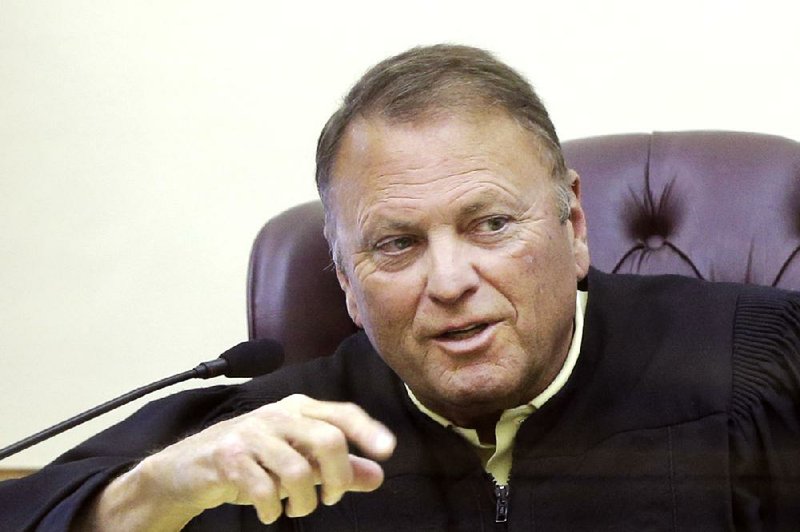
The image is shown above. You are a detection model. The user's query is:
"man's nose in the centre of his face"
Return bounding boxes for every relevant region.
[426,236,480,304]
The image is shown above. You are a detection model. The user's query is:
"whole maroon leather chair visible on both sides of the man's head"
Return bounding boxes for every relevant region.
[248,132,800,364]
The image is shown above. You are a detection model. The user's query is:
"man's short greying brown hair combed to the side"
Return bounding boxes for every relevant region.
[316,44,570,262]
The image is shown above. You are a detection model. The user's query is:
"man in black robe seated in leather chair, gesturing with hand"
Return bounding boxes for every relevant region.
[0,46,800,531]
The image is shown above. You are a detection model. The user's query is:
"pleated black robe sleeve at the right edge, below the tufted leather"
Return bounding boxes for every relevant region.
[730,291,800,531]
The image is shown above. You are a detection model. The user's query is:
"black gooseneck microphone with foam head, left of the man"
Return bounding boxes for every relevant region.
[0,339,283,460]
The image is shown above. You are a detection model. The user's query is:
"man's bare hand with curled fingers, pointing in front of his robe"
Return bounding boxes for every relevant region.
[80,395,395,530]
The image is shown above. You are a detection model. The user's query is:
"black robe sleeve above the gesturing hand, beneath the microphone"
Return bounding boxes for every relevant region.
[0,386,236,532]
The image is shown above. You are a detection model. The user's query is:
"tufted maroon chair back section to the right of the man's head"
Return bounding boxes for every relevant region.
[564,132,800,284]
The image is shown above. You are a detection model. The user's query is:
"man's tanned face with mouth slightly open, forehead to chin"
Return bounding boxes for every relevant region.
[330,114,589,426]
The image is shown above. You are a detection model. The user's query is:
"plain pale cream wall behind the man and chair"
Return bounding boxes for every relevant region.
[0,0,800,467]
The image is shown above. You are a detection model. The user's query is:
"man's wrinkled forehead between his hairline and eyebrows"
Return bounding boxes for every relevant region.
[331,112,550,202]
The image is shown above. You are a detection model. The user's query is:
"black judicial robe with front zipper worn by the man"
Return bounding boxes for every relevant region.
[0,270,800,532]
